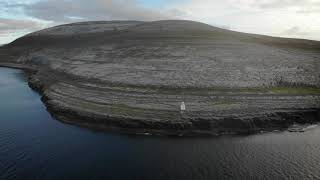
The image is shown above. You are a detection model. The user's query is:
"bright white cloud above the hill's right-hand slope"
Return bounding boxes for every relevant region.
[168,0,320,40]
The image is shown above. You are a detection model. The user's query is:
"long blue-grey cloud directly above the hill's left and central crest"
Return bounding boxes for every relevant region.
[16,0,169,22]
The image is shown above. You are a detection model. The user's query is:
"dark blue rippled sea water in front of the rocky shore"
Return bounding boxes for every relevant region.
[0,68,320,180]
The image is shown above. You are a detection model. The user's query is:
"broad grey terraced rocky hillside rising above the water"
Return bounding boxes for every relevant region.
[0,21,320,133]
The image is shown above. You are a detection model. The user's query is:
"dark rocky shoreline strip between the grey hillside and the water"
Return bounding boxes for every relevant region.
[0,63,320,136]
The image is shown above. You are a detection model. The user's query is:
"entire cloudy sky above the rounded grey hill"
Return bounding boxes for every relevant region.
[0,0,320,44]
